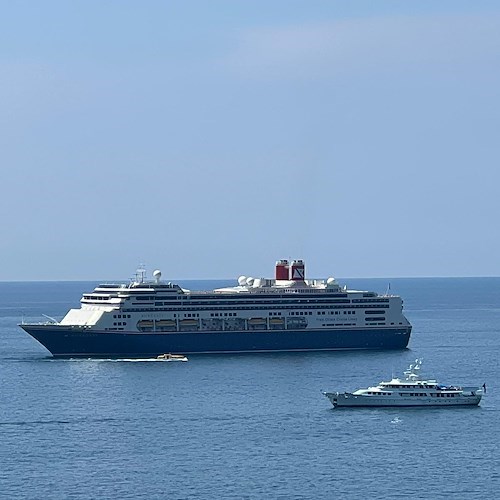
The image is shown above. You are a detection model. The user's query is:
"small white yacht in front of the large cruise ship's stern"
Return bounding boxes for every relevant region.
[323,359,486,407]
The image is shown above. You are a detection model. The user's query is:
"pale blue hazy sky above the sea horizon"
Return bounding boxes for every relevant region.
[0,0,500,281]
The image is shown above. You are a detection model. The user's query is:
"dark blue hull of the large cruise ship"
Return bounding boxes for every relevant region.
[20,325,411,358]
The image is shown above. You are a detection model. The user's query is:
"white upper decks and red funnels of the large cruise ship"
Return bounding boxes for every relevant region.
[51,260,411,333]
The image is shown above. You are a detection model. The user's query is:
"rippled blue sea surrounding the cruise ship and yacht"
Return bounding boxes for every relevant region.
[0,278,500,499]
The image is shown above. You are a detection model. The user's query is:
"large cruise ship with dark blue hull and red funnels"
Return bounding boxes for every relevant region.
[19,260,412,358]
